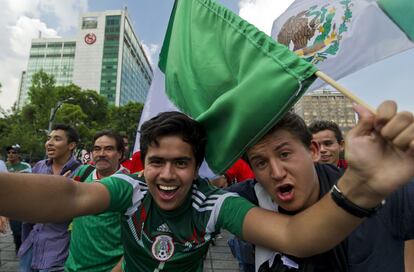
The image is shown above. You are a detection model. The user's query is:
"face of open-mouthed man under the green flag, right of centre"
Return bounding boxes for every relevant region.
[246,129,319,211]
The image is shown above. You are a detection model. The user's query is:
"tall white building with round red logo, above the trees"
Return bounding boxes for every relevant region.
[18,10,153,107]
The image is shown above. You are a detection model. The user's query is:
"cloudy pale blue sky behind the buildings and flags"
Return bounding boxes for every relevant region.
[0,0,414,112]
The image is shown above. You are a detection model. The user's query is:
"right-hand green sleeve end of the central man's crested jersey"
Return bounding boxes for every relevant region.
[217,194,256,238]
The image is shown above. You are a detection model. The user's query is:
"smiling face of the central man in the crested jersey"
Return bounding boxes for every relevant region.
[144,136,198,211]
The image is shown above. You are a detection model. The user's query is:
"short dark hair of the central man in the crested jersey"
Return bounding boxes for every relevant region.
[139,111,207,167]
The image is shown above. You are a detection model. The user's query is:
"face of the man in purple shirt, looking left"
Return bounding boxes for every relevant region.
[45,129,76,161]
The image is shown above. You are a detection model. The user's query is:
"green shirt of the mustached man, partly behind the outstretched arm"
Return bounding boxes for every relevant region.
[65,165,125,272]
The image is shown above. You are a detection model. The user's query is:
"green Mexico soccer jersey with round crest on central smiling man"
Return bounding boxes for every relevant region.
[100,174,254,272]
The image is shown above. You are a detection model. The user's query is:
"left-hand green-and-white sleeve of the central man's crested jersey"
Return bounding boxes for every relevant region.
[99,174,144,216]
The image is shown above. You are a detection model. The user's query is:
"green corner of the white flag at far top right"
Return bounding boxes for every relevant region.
[378,0,414,41]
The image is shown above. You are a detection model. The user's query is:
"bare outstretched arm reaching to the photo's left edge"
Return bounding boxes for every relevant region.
[0,173,110,222]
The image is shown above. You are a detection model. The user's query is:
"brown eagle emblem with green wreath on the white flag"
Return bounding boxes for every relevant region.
[277,0,353,64]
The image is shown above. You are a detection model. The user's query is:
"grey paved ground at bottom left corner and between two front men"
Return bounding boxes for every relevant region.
[0,231,238,272]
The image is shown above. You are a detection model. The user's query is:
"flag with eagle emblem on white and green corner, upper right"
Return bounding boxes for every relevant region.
[271,0,414,89]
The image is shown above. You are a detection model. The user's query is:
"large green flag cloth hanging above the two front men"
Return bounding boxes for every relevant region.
[159,0,317,173]
